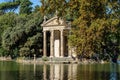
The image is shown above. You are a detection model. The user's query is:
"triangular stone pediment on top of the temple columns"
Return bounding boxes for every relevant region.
[42,16,66,27]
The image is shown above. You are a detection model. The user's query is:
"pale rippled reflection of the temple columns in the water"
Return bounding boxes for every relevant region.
[43,64,77,80]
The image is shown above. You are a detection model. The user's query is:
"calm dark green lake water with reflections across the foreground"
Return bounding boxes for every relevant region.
[0,62,120,80]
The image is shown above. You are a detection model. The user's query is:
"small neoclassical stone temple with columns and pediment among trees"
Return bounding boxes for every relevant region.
[41,15,71,57]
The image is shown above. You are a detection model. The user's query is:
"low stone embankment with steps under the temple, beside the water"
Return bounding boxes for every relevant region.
[16,57,105,64]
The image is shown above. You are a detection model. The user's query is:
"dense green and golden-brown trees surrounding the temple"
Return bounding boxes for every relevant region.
[0,0,120,60]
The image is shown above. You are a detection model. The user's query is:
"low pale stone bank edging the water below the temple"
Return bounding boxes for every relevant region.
[16,59,109,64]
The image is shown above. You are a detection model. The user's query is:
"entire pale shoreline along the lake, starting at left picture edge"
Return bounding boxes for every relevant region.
[0,57,109,64]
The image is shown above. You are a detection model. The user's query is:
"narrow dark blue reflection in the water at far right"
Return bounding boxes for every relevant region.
[110,63,117,80]
